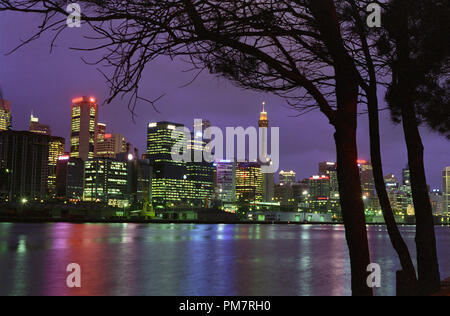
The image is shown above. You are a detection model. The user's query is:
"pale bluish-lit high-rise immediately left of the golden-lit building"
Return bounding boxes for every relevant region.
[216,160,236,203]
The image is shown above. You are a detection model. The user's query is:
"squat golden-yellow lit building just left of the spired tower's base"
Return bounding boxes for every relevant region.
[236,162,263,203]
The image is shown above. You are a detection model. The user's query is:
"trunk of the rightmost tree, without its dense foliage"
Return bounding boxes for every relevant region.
[394,0,441,295]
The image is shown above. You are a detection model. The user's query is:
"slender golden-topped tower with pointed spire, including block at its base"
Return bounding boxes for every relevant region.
[258,102,275,202]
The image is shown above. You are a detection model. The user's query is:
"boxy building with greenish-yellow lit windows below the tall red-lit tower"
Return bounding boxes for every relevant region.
[83,158,129,208]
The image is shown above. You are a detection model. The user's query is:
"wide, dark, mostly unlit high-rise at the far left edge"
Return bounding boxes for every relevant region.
[0,131,50,202]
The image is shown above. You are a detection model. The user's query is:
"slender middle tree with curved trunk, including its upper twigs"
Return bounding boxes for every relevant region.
[340,0,417,295]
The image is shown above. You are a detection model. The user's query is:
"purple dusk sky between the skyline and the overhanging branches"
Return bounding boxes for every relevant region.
[0,13,450,188]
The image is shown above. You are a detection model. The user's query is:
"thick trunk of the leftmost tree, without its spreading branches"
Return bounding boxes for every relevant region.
[308,0,373,296]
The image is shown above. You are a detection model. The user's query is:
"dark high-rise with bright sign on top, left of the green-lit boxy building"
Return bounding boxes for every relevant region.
[56,155,84,201]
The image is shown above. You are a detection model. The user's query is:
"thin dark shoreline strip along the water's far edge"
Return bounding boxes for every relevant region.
[0,217,450,227]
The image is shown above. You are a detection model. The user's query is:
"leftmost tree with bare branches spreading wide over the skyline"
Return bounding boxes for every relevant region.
[0,0,400,295]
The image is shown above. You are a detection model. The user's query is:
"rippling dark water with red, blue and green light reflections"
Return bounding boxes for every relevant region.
[0,223,450,296]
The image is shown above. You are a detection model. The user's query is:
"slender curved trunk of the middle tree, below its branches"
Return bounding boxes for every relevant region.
[368,88,417,296]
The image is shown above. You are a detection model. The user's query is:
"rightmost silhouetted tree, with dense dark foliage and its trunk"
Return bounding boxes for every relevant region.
[378,0,450,294]
